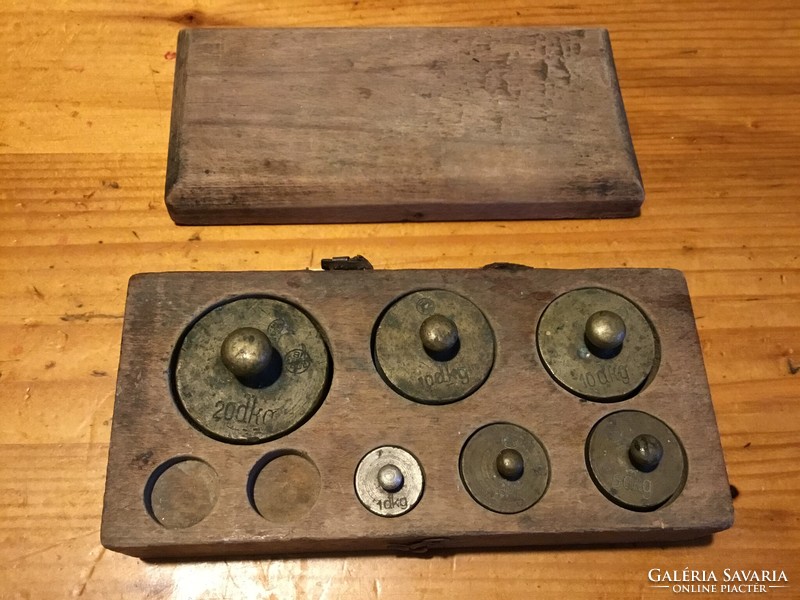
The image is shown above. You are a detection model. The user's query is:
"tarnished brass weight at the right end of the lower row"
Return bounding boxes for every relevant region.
[586,410,686,510]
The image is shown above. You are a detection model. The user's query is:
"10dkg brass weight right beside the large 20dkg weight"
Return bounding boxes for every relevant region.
[373,290,494,404]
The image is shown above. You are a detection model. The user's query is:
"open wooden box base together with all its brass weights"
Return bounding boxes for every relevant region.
[102,268,733,557]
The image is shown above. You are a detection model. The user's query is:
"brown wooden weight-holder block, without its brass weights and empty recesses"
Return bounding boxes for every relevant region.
[101,269,733,557]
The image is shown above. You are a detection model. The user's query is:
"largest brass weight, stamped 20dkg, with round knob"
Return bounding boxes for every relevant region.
[174,297,330,443]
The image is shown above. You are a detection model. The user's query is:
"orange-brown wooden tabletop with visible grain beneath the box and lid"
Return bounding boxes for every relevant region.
[0,0,800,599]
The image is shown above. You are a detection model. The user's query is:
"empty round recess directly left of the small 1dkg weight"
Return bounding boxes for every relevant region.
[250,451,322,523]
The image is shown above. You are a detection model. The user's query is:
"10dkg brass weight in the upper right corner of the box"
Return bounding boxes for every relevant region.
[536,288,658,402]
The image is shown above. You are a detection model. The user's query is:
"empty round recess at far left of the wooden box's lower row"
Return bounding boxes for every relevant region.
[145,458,219,529]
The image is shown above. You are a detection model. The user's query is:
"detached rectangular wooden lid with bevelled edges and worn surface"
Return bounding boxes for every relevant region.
[166,28,644,225]
